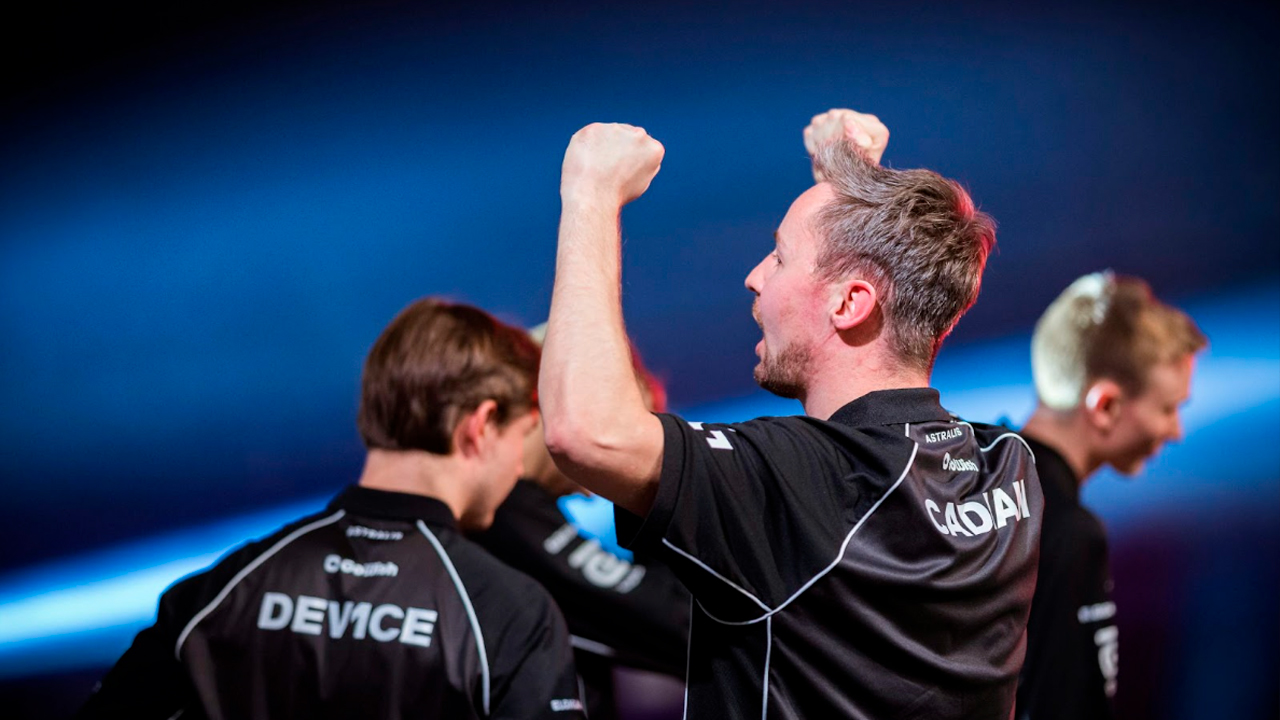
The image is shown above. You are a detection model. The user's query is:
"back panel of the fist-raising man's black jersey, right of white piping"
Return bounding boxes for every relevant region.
[773,421,1043,719]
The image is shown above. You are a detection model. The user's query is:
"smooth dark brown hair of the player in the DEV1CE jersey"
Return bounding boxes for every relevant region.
[358,299,541,455]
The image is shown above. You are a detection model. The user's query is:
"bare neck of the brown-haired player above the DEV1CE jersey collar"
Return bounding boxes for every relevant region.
[360,450,472,521]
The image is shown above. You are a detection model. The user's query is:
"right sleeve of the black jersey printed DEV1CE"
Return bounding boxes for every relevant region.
[490,582,586,720]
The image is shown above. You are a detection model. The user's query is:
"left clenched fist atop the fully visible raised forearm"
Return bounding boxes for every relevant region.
[561,123,666,208]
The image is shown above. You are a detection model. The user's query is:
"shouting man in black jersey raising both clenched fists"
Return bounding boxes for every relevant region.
[539,110,1043,720]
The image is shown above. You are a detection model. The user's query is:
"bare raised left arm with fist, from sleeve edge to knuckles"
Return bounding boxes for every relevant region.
[538,123,663,516]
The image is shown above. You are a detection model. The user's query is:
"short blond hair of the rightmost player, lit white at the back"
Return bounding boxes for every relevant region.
[1032,270,1208,410]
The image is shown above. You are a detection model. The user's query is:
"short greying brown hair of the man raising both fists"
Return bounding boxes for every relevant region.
[814,142,996,370]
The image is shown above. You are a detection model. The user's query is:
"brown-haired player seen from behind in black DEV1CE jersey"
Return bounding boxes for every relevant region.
[79,299,582,720]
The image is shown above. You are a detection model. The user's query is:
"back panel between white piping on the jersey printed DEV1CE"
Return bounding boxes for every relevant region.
[177,510,485,717]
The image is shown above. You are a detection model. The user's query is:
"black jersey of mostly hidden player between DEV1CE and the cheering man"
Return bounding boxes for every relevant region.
[472,480,689,720]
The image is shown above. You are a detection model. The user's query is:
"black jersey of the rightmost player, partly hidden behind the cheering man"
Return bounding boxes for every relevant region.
[1018,436,1120,720]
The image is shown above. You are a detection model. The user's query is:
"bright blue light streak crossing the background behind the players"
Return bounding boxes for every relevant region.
[0,287,1280,678]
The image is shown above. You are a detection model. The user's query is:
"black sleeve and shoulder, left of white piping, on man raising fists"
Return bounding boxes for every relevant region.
[617,415,905,621]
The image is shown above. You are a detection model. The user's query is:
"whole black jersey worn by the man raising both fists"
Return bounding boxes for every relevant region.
[617,388,1043,720]
